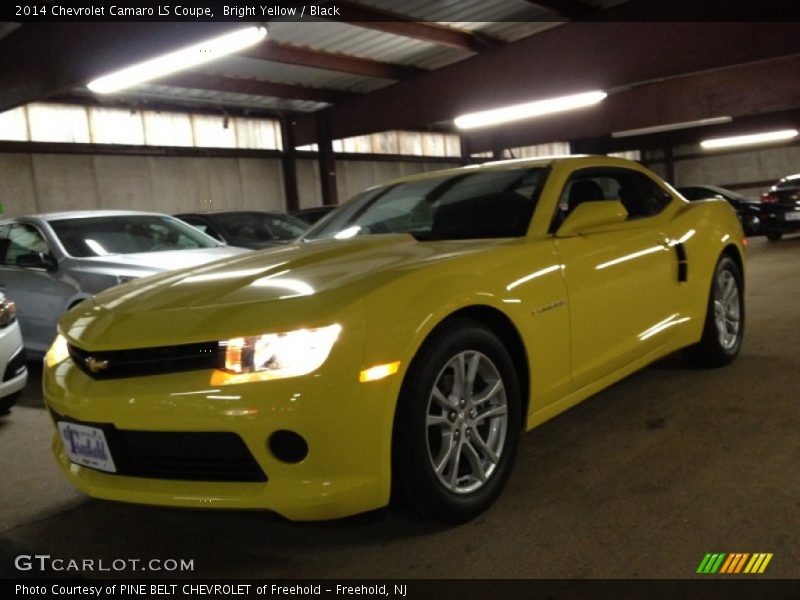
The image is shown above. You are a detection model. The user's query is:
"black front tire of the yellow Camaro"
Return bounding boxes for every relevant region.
[392,319,522,525]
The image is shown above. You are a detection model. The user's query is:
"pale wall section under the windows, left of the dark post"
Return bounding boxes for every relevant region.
[0,154,284,216]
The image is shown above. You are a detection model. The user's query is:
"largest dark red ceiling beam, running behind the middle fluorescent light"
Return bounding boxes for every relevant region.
[297,23,800,145]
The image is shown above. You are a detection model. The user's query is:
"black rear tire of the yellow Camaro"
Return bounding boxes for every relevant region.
[683,255,745,368]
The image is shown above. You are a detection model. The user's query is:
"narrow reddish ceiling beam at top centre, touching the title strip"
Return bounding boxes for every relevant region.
[336,0,504,52]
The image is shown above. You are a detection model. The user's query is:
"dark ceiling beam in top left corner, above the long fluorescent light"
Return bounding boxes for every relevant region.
[0,22,241,111]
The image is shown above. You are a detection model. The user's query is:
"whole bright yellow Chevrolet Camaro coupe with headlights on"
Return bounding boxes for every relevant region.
[44,157,744,523]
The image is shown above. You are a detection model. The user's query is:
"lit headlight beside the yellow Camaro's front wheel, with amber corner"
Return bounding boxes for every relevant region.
[221,324,342,383]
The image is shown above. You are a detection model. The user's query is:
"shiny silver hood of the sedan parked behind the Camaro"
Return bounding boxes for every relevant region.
[79,246,247,273]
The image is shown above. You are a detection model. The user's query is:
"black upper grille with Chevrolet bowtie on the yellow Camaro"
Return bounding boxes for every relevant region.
[69,342,219,379]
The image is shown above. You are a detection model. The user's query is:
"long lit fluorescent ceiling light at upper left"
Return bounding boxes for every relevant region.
[86,27,267,94]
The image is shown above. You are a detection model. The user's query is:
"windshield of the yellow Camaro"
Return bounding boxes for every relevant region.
[304,168,545,240]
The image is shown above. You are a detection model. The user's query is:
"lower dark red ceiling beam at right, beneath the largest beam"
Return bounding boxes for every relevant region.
[469,54,800,152]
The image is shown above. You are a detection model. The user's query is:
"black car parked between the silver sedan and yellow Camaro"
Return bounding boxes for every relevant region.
[175,210,308,250]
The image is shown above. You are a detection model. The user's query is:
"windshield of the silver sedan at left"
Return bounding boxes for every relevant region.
[50,215,219,258]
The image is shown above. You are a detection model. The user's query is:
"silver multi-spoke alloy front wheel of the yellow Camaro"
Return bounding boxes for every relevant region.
[426,350,508,494]
